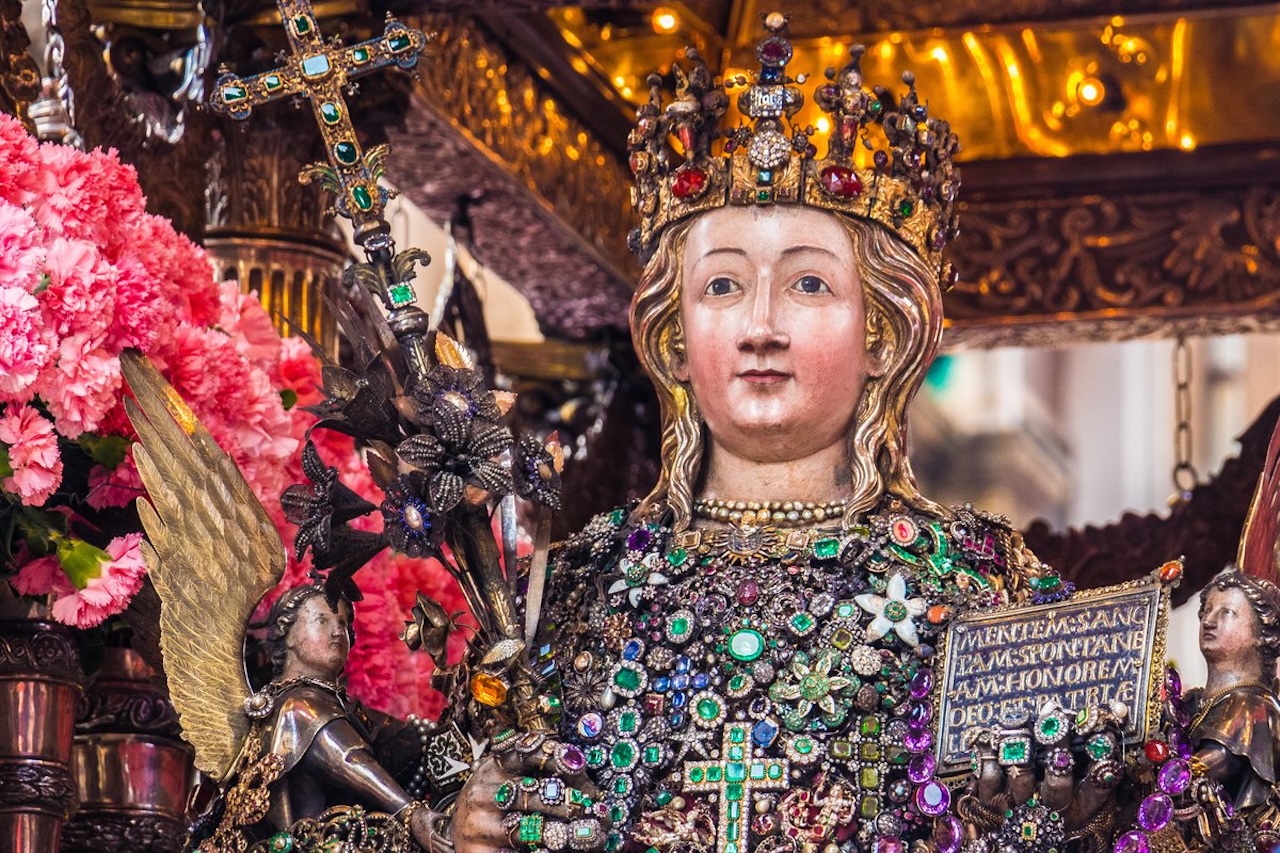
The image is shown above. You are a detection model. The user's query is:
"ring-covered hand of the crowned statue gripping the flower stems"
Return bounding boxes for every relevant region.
[453,734,609,853]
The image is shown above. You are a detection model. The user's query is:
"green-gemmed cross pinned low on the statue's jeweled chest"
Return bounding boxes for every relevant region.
[681,722,788,853]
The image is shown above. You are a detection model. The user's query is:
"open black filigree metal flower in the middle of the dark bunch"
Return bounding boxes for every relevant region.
[396,405,511,512]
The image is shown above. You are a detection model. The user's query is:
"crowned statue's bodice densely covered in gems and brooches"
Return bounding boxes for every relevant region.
[544,500,1056,853]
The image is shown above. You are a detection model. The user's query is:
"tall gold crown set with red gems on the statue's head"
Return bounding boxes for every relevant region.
[627,13,960,282]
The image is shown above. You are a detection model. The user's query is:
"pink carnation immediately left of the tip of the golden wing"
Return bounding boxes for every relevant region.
[36,334,122,438]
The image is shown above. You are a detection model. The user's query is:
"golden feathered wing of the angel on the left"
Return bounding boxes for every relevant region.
[120,352,285,780]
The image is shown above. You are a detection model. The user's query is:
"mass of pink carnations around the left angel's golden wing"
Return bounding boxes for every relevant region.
[0,114,461,713]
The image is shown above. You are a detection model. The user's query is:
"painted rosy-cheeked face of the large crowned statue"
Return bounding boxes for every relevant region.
[676,206,869,462]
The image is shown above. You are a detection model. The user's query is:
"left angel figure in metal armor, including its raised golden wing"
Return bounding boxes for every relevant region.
[122,353,449,853]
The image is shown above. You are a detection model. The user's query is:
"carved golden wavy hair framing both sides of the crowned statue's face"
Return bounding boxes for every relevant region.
[631,214,942,530]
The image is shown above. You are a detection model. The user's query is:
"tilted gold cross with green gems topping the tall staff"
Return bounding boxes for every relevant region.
[210,0,428,252]
